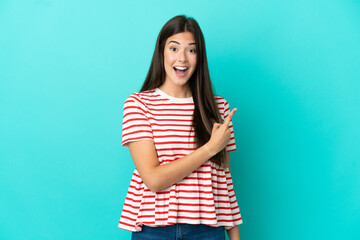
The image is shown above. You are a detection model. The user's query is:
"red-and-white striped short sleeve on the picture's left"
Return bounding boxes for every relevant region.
[121,94,153,147]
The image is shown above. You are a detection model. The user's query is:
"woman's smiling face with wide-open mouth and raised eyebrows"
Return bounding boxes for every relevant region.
[164,32,196,86]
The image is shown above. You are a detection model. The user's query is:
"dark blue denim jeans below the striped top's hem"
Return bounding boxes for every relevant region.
[131,224,225,240]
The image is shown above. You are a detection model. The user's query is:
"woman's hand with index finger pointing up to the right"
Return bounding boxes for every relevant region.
[205,108,237,155]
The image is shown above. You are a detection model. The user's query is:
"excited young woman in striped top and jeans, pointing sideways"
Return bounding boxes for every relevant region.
[118,16,242,240]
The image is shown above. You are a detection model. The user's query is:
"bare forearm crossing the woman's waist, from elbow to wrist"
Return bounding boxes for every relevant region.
[151,143,214,192]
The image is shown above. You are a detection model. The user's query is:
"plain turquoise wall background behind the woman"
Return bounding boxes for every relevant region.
[0,0,360,240]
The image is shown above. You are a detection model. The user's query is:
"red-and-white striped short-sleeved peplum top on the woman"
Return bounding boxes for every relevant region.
[118,88,242,232]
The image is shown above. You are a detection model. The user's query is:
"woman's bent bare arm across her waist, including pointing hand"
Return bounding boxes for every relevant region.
[128,108,236,192]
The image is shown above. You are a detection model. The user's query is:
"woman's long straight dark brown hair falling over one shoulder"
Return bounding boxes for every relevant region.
[140,15,226,166]
